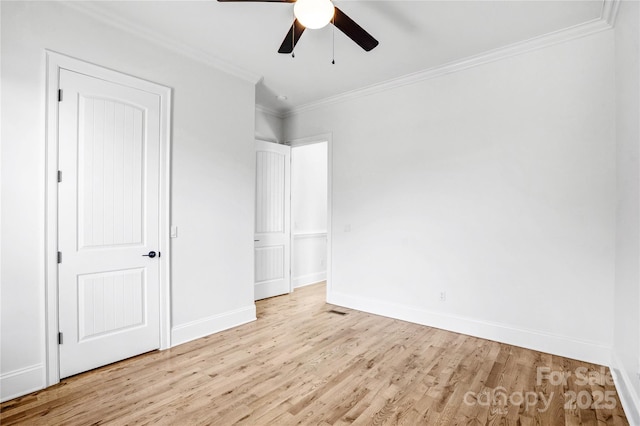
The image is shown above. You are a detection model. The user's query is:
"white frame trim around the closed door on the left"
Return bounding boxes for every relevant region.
[43,50,172,386]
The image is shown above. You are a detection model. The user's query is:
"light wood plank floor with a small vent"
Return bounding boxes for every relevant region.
[0,284,628,425]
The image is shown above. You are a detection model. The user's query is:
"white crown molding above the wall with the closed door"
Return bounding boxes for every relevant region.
[60,1,262,85]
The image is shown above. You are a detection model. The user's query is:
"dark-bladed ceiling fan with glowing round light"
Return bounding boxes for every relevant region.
[218,0,378,53]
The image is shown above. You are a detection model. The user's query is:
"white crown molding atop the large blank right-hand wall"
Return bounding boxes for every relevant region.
[283,0,621,118]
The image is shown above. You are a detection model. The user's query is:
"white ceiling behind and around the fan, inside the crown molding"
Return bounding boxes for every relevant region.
[69,0,604,113]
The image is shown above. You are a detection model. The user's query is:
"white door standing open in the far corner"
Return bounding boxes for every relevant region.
[254,141,291,300]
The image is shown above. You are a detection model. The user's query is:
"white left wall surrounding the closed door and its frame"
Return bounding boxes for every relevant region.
[0,2,255,400]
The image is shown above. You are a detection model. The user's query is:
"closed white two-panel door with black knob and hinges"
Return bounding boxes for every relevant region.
[58,70,161,377]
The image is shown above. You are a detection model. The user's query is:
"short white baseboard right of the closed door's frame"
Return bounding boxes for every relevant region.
[171,305,256,347]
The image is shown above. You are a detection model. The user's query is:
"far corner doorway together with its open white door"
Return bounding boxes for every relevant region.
[254,134,331,300]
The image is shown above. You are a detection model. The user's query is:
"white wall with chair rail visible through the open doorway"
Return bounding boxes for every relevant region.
[291,142,328,287]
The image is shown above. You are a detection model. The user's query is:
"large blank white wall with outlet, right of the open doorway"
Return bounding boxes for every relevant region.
[285,31,616,364]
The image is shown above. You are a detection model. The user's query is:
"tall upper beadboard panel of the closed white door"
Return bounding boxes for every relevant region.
[78,98,144,249]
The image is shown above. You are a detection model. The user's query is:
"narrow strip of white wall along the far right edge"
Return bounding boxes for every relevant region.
[613,1,640,424]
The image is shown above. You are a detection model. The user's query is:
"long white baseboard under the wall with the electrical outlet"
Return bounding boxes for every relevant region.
[327,291,611,366]
